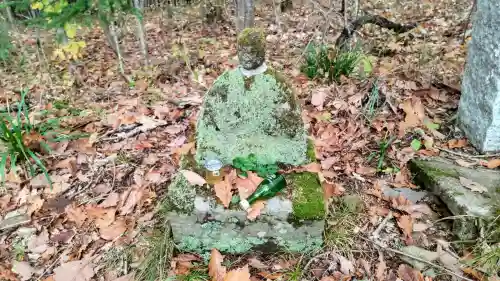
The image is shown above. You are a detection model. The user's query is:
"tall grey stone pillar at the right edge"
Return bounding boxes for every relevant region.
[458,0,500,152]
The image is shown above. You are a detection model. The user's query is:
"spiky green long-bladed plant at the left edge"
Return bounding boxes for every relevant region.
[0,90,84,183]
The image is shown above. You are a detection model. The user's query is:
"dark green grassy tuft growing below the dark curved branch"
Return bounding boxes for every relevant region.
[301,42,363,83]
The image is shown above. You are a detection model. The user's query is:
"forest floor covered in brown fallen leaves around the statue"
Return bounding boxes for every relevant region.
[0,0,492,281]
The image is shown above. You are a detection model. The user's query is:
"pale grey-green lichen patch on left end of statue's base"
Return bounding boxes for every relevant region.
[163,173,196,214]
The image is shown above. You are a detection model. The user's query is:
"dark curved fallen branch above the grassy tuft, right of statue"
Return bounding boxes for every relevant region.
[335,14,417,48]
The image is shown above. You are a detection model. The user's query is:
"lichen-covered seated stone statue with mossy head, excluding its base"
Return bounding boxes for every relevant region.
[196,28,307,165]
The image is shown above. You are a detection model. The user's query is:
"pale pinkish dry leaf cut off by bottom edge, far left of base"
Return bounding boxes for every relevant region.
[54,260,95,281]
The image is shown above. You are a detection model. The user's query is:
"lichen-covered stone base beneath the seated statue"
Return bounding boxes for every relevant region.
[167,170,325,254]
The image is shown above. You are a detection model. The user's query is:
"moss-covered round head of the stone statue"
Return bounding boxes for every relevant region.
[238,28,266,70]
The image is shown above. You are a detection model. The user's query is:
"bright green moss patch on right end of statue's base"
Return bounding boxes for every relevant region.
[286,172,325,220]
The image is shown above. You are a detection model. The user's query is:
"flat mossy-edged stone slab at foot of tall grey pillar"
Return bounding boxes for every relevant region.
[410,157,500,240]
